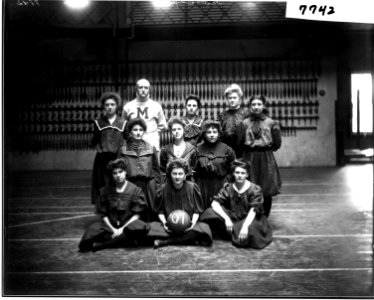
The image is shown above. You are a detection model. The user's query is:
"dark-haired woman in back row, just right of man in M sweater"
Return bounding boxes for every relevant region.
[183,94,204,146]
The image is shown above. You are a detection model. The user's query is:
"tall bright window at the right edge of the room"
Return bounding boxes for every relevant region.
[351,73,373,133]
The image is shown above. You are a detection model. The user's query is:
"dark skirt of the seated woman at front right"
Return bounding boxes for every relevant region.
[200,208,273,249]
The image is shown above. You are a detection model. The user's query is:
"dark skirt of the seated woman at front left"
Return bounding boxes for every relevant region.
[79,220,149,251]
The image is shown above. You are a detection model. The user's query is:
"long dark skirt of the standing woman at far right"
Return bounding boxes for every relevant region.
[243,151,282,197]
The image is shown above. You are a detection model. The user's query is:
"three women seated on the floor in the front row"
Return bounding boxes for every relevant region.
[79,158,272,252]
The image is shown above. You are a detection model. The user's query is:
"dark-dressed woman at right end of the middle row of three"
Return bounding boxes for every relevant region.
[195,121,235,209]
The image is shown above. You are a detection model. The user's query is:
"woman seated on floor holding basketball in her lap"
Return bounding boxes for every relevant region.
[148,158,212,248]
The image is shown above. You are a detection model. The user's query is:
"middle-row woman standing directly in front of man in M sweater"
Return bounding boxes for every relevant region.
[118,118,161,221]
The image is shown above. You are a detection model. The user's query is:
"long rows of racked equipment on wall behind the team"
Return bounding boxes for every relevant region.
[15,59,321,151]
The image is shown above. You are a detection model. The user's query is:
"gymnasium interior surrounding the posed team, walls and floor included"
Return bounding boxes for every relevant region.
[2,0,374,298]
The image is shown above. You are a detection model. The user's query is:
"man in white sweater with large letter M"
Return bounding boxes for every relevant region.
[123,78,167,152]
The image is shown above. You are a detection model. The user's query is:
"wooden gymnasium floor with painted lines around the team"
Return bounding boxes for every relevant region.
[3,164,374,297]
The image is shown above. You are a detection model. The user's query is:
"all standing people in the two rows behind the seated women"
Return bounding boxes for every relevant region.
[92,79,281,221]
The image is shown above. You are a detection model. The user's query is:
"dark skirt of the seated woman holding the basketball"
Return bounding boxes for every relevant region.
[147,222,213,246]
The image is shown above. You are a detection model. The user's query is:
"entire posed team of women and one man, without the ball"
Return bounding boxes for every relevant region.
[79,79,281,251]
